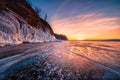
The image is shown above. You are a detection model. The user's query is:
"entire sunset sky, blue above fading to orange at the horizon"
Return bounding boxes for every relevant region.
[30,0,120,40]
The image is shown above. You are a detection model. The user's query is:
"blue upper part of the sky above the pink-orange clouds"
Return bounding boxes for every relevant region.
[30,0,120,20]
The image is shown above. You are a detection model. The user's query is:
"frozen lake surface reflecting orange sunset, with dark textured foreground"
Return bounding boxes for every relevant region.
[0,41,120,80]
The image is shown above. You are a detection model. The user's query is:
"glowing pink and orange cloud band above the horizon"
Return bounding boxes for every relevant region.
[51,13,120,39]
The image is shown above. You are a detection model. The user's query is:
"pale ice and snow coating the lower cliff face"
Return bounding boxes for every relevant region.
[0,11,56,44]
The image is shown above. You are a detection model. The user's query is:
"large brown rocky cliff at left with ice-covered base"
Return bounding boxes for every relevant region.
[0,0,55,44]
